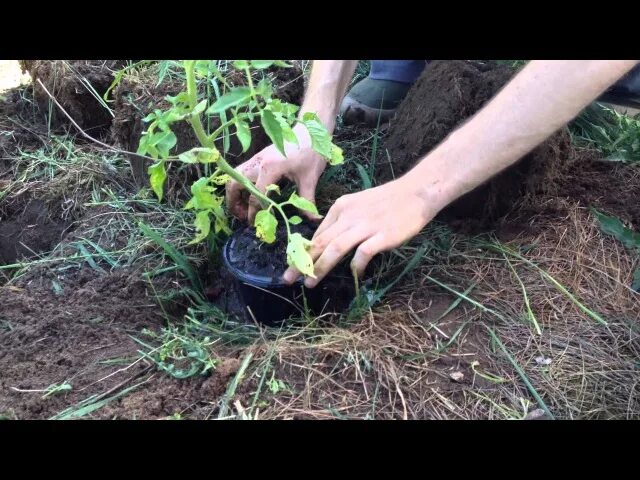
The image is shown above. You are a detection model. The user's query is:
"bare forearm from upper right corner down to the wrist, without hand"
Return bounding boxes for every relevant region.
[406,60,637,214]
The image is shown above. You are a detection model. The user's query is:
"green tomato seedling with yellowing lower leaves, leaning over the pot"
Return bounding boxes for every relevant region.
[137,60,343,277]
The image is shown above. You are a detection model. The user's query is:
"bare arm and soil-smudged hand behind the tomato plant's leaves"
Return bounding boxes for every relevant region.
[227,60,357,222]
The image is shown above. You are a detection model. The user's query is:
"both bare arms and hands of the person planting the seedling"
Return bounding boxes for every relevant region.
[227,60,638,288]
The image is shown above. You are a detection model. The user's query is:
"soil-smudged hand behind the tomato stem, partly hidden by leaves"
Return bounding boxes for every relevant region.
[226,124,327,224]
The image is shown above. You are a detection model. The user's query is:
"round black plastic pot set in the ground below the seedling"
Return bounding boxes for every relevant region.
[222,231,331,326]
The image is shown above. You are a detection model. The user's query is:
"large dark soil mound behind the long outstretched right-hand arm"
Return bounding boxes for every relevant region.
[379,61,574,229]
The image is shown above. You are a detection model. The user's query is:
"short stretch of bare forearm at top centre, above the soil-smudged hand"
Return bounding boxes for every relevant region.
[300,60,358,132]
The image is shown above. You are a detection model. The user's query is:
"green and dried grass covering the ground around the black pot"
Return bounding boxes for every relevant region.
[0,61,640,419]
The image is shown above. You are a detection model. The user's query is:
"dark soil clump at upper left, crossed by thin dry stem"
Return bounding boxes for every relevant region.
[20,60,126,135]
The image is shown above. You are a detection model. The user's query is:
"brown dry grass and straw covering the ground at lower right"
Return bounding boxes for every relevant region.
[232,207,640,419]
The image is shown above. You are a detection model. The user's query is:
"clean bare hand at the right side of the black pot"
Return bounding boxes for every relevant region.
[283,175,438,288]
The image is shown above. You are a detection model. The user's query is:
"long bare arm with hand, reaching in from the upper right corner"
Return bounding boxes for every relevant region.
[284,60,638,287]
